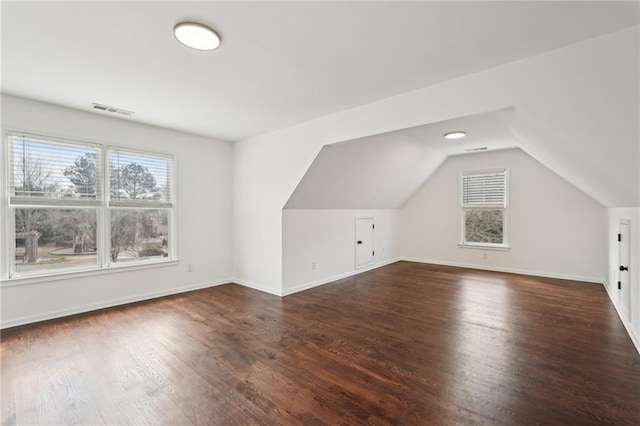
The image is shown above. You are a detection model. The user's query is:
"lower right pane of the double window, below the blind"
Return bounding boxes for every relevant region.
[111,209,169,263]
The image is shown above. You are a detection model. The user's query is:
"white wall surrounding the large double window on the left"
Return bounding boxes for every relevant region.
[0,95,232,327]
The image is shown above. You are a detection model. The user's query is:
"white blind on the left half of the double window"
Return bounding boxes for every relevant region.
[8,132,102,206]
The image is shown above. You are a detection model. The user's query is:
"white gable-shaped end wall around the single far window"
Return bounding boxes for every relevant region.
[400,149,607,283]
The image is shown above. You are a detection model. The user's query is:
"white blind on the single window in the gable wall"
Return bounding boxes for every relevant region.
[461,169,507,208]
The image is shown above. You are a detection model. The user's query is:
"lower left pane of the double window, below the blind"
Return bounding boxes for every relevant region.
[13,208,98,274]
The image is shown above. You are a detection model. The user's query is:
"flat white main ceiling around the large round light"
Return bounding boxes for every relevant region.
[1,1,638,141]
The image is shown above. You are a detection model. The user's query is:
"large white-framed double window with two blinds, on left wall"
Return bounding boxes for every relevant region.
[7,132,175,278]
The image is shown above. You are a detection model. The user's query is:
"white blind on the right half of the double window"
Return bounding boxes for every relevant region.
[107,147,173,208]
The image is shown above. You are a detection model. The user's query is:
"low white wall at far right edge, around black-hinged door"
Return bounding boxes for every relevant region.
[606,207,640,352]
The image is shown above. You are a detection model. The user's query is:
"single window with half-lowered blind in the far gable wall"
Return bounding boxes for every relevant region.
[460,169,507,248]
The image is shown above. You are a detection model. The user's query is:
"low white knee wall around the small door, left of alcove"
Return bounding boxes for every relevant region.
[282,209,400,295]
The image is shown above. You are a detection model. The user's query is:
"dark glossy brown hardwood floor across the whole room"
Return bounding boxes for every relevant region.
[1,262,640,425]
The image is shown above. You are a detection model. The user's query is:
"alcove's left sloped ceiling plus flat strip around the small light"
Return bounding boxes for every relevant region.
[285,108,518,209]
